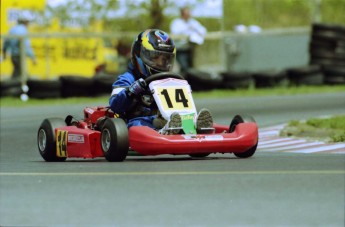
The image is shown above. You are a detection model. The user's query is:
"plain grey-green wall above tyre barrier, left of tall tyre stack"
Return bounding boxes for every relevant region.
[195,28,310,72]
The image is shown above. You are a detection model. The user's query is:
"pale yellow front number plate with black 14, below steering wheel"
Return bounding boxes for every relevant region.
[157,87,193,111]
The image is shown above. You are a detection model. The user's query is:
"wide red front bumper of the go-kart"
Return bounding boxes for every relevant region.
[129,122,258,155]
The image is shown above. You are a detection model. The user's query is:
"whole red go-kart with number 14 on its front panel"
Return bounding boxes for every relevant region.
[37,73,258,162]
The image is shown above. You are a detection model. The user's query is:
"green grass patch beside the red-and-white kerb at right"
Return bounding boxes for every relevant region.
[280,115,345,142]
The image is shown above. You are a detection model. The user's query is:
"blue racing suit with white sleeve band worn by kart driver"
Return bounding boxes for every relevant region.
[109,63,157,129]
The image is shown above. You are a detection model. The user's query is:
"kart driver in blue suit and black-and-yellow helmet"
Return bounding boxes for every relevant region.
[109,29,213,134]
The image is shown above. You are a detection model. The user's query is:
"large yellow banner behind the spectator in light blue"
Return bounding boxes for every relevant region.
[0,0,118,79]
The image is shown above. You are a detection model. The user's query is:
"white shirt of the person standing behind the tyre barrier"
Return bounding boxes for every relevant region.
[170,18,207,47]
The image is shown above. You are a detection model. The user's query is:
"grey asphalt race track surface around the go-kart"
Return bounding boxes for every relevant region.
[0,92,345,226]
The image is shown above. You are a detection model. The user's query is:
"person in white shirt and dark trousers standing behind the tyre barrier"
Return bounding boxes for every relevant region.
[170,7,207,73]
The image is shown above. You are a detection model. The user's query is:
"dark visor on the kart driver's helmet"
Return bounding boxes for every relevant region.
[140,47,175,72]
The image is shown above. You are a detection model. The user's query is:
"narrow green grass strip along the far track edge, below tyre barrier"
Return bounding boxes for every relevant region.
[0,86,345,107]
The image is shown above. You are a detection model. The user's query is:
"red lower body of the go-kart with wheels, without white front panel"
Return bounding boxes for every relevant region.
[38,107,258,161]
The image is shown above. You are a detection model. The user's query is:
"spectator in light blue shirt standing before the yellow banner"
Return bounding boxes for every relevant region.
[2,18,36,79]
